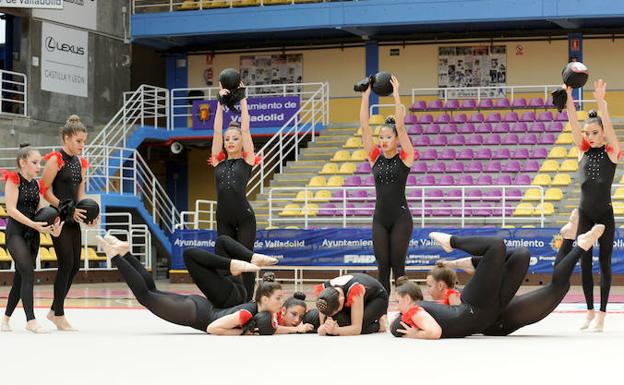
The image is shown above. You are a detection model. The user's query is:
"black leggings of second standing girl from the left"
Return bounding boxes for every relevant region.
[51,222,82,316]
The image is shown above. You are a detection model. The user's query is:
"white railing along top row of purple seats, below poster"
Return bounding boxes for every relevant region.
[412,85,561,103]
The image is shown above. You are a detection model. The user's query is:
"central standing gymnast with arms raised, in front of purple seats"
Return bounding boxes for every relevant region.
[360,76,415,293]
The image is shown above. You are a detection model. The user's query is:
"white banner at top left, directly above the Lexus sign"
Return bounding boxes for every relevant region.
[33,0,97,30]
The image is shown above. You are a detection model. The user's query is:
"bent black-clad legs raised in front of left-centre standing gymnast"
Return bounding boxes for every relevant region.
[183,235,253,308]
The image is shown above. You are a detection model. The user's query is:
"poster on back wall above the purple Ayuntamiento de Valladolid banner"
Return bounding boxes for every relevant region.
[240,54,303,94]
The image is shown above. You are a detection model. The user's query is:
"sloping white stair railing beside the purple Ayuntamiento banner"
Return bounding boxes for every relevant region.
[247,83,329,196]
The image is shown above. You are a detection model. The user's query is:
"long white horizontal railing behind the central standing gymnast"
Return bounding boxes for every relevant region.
[268,185,544,228]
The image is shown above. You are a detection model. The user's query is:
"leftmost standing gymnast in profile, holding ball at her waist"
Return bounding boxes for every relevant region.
[0,145,63,333]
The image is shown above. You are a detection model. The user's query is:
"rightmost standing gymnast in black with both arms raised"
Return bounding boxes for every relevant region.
[567,79,621,331]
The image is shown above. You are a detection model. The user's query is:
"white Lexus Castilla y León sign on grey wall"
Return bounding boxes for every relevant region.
[41,22,89,97]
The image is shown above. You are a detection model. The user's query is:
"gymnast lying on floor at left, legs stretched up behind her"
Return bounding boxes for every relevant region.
[98,232,282,335]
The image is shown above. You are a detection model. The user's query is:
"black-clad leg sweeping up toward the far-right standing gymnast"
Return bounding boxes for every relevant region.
[484,239,584,336]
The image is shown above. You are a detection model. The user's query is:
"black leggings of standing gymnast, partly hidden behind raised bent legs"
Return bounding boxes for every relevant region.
[217,211,256,301]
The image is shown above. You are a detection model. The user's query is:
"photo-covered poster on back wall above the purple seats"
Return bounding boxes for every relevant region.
[438,45,507,99]
